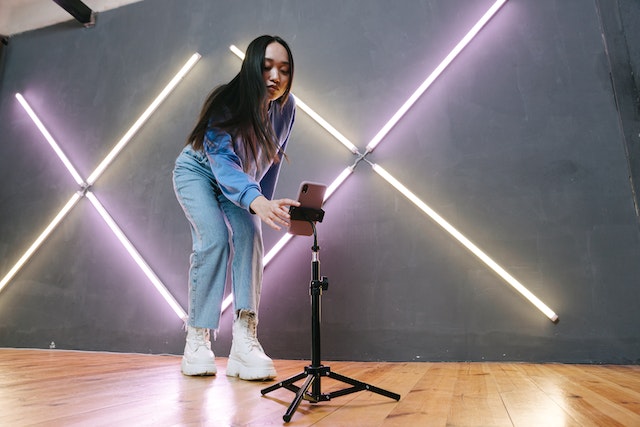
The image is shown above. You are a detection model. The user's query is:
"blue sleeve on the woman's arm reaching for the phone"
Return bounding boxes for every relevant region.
[204,128,262,210]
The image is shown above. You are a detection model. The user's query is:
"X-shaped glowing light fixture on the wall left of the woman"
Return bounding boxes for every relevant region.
[0,53,201,319]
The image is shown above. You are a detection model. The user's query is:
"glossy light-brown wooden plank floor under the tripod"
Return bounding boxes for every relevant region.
[0,349,640,427]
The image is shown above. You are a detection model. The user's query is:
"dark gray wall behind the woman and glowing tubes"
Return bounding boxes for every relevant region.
[0,0,640,363]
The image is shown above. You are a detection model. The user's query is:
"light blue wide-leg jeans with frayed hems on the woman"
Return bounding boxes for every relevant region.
[173,146,264,330]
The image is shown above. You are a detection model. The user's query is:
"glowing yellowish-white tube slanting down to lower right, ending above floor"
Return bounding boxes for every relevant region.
[371,164,558,323]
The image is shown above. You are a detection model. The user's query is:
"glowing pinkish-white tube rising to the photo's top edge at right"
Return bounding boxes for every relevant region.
[366,0,507,153]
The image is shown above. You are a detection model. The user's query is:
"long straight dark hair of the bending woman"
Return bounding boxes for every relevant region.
[187,35,293,170]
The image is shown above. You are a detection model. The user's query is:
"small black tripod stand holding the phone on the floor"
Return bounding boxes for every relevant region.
[261,212,400,422]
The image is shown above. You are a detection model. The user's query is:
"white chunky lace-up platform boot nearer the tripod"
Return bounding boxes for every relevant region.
[227,311,277,380]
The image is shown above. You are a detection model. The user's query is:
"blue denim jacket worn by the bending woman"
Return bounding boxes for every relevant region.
[204,94,296,209]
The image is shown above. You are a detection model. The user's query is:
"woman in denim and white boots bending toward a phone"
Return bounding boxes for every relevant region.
[173,36,299,380]
